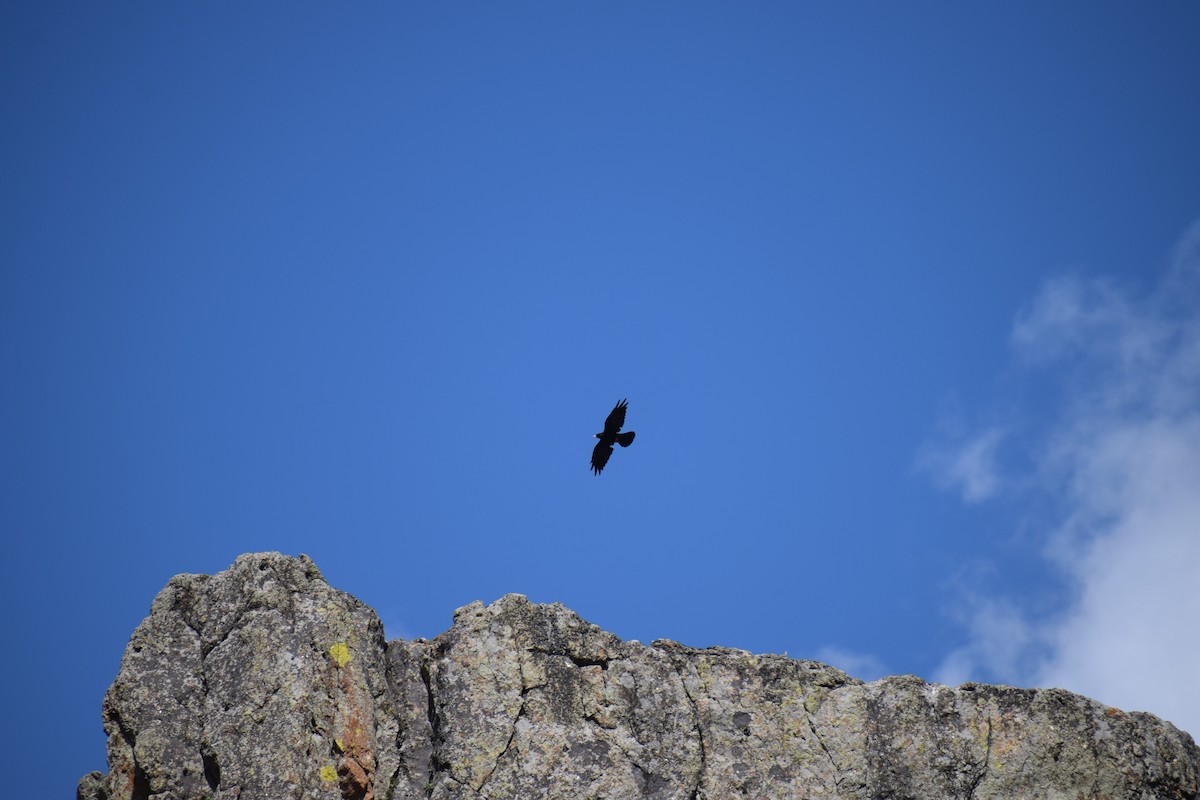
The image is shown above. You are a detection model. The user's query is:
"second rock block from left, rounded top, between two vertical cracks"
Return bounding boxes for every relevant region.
[428,595,702,798]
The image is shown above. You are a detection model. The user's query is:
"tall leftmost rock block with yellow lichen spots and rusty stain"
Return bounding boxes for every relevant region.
[94,554,397,800]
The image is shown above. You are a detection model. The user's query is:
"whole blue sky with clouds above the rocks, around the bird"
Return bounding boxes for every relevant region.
[0,2,1200,796]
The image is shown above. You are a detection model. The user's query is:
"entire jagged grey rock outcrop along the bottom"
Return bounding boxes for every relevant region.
[78,553,1200,800]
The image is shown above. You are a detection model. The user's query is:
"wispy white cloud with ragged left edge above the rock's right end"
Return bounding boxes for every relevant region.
[940,224,1200,734]
